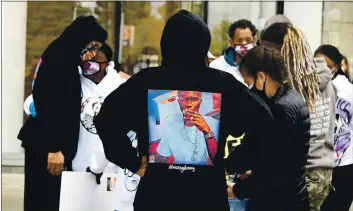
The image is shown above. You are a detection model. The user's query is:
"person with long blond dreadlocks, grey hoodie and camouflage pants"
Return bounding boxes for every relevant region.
[262,23,336,211]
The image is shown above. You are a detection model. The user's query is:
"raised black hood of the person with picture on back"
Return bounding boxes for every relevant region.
[161,10,211,67]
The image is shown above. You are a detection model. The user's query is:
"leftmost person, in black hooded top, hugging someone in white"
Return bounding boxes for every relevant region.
[18,16,107,211]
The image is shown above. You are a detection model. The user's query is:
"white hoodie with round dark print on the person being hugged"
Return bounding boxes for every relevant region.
[24,62,137,173]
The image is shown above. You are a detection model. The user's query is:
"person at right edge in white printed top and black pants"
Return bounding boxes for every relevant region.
[315,45,353,211]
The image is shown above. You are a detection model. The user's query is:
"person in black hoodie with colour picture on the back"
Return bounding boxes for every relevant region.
[94,10,273,211]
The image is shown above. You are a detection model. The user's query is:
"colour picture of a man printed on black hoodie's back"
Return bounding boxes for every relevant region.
[148,90,221,166]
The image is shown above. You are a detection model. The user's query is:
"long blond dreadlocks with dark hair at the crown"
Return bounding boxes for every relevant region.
[263,23,320,110]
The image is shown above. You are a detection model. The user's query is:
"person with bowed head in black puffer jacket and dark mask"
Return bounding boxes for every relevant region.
[233,46,310,211]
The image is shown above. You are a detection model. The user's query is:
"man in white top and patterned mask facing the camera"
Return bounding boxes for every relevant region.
[210,19,257,86]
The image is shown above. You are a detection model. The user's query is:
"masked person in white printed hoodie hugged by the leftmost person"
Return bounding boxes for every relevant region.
[72,44,132,173]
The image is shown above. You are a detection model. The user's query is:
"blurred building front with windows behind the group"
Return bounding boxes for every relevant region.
[1,1,353,166]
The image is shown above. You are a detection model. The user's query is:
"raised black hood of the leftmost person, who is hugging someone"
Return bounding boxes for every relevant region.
[42,16,107,63]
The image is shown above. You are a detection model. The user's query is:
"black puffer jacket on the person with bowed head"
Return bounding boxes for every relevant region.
[269,88,311,194]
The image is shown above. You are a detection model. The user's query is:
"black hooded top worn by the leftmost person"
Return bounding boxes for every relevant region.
[18,16,107,163]
